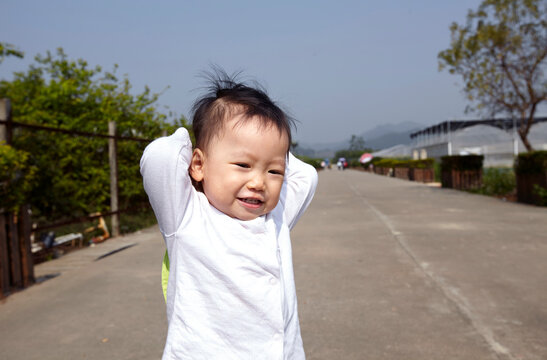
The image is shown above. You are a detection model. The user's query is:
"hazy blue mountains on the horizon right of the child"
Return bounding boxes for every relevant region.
[294,121,425,158]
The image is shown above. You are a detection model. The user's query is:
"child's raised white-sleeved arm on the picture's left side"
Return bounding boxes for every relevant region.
[141,128,192,237]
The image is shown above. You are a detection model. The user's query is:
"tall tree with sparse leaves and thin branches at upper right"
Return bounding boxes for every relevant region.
[438,0,547,151]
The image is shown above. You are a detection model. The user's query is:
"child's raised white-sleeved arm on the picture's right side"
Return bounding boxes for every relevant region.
[279,153,317,229]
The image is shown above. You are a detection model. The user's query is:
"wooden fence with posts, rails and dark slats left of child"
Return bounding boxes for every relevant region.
[0,99,151,298]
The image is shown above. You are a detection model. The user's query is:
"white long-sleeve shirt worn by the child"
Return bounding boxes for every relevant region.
[141,128,317,360]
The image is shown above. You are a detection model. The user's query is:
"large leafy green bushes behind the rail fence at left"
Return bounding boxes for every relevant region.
[0,49,185,220]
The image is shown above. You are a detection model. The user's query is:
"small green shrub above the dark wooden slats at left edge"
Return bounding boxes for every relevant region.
[0,142,36,212]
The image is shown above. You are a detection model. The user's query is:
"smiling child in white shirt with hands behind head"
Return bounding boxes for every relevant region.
[141,73,317,359]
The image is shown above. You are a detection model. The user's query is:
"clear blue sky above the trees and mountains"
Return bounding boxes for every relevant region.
[0,0,480,144]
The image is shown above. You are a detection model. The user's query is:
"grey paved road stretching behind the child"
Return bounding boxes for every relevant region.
[0,170,547,360]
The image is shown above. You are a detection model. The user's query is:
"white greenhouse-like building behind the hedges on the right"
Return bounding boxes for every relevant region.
[410,117,547,167]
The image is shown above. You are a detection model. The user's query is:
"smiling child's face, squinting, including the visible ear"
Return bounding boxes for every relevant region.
[190,116,289,220]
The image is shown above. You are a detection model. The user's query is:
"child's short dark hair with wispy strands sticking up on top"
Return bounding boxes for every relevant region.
[192,67,294,151]
